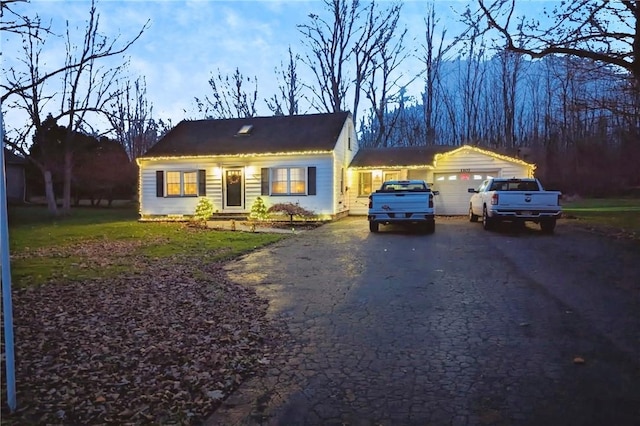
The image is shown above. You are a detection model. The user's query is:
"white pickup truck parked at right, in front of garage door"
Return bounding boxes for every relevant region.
[469,178,562,233]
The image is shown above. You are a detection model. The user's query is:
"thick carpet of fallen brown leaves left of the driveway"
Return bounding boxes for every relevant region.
[2,241,282,425]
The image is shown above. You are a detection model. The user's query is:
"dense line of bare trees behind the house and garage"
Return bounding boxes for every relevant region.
[196,0,640,195]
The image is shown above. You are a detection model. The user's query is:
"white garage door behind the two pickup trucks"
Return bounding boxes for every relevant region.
[433,171,498,215]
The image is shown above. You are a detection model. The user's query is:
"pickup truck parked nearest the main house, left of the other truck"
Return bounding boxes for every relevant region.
[368,180,438,233]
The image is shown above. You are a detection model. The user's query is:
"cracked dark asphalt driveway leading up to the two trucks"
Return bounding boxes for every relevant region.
[207,218,640,425]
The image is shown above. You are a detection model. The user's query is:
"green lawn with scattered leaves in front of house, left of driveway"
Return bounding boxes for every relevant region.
[9,206,285,286]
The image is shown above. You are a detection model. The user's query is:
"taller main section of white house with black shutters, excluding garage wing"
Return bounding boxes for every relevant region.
[137,112,358,220]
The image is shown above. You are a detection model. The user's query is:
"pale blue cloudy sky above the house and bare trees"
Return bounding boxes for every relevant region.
[2,0,549,135]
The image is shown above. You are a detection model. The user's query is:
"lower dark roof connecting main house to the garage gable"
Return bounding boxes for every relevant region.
[351,145,459,167]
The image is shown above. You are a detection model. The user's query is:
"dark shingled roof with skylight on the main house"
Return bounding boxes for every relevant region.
[142,112,350,158]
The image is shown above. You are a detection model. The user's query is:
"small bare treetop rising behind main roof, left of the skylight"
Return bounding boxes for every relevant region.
[195,68,258,118]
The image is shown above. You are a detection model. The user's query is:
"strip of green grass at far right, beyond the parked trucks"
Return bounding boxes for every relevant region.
[563,198,640,238]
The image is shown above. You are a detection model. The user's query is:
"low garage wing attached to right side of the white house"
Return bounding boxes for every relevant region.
[348,145,535,215]
